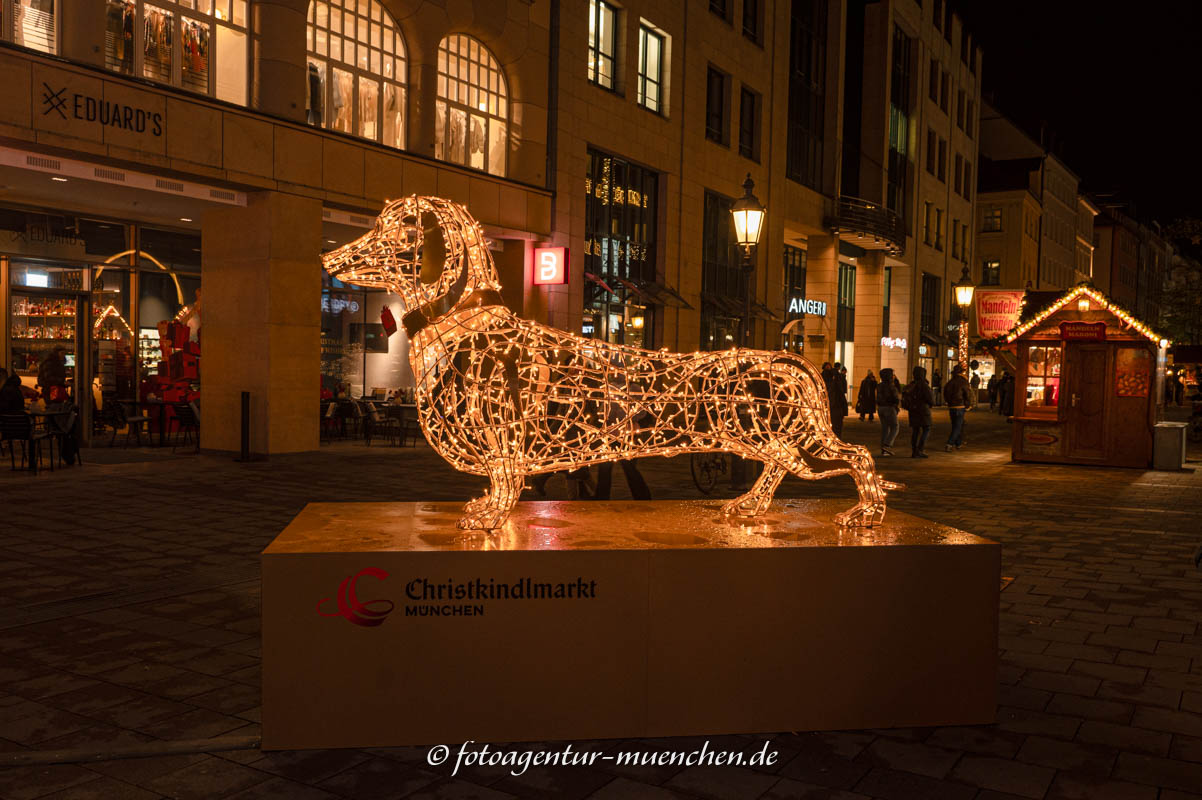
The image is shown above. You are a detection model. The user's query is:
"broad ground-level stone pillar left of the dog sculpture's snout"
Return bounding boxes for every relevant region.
[201,192,321,455]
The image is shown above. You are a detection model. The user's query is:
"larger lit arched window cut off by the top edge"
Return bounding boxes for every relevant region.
[305,0,406,148]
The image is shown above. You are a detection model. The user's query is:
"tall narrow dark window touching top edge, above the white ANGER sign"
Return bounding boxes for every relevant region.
[785,0,827,189]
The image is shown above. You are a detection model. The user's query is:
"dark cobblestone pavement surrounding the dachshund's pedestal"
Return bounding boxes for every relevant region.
[0,410,1202,800]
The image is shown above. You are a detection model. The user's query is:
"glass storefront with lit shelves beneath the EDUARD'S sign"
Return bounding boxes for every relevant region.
[0,209,201,437]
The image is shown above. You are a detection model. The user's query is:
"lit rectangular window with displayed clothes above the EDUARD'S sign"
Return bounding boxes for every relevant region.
[105,0,249,106]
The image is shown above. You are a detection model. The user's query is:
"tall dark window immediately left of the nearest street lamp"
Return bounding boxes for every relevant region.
[701,191,748,350]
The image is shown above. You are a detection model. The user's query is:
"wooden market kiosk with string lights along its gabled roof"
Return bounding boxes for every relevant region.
[1006,283,1168,467]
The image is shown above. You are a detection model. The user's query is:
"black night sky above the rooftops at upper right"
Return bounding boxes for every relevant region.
[966,0,1202,222]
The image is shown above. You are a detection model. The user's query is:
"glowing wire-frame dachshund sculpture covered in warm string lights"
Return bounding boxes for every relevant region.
[322,197,899,530]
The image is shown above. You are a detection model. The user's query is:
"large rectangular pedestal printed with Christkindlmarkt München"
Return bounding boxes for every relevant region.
[262,501,1000,750]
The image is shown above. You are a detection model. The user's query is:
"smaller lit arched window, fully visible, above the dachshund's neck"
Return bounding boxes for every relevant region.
[434,34,508,175]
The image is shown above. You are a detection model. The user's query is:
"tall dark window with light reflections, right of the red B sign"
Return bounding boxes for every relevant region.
[582,148,660,347]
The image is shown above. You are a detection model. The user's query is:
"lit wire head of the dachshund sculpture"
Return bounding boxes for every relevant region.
[321,195,500,321]
